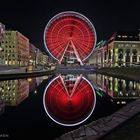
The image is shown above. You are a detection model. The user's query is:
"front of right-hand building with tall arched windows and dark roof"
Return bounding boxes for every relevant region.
[108,31,140,67]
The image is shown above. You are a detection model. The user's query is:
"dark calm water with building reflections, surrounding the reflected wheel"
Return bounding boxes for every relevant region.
[0,74,140,140]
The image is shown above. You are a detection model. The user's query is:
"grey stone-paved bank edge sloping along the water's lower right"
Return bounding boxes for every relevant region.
[55,99,140,140]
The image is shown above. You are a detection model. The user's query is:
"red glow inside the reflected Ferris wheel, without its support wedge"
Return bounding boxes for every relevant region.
[44,77,96,124]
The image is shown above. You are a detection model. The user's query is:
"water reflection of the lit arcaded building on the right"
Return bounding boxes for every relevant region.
[89,74,140,99]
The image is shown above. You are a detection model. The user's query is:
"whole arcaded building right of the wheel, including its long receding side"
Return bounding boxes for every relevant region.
[90,31,140,67]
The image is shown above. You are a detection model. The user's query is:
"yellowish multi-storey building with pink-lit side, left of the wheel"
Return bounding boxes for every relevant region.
[0,31,29,67]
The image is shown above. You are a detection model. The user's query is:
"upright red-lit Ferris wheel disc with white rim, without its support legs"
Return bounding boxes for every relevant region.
[44,11,97,61]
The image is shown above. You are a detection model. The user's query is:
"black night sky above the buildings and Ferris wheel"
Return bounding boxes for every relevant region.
[0,0,140,50]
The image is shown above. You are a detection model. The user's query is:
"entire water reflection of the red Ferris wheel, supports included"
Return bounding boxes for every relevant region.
[43,74,96,126]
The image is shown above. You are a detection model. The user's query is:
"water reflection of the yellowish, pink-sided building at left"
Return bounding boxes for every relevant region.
[0,80,29,106]
